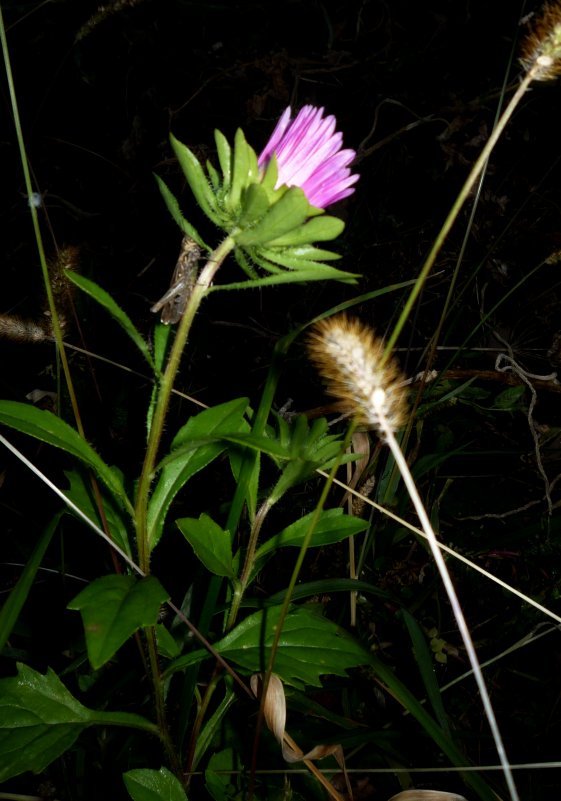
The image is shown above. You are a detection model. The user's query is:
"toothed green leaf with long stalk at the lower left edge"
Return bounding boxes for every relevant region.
[0,665,158,781]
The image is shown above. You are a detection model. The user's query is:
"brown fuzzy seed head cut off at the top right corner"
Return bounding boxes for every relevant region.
[520,0,561,81]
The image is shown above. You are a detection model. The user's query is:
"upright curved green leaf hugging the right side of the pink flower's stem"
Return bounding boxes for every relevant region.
[148,398,248,549]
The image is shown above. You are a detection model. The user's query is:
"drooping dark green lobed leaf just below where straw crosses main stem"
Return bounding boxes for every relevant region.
[68,575,169,670]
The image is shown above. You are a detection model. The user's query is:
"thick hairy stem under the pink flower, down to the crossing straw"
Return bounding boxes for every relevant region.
[135,237,235,574]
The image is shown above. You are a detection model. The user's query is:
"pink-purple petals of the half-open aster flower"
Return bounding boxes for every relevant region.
[258,106,358,209]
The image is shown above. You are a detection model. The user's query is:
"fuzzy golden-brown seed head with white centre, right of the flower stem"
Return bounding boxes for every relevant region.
[308,314,407,434]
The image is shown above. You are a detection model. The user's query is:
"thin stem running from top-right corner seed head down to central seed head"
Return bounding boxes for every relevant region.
[384,65,542,359]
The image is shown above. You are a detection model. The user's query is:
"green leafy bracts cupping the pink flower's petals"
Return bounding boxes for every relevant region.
[158,129,358,288]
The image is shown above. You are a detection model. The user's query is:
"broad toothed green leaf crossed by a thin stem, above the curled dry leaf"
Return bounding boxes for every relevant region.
[215,606,370,688]
